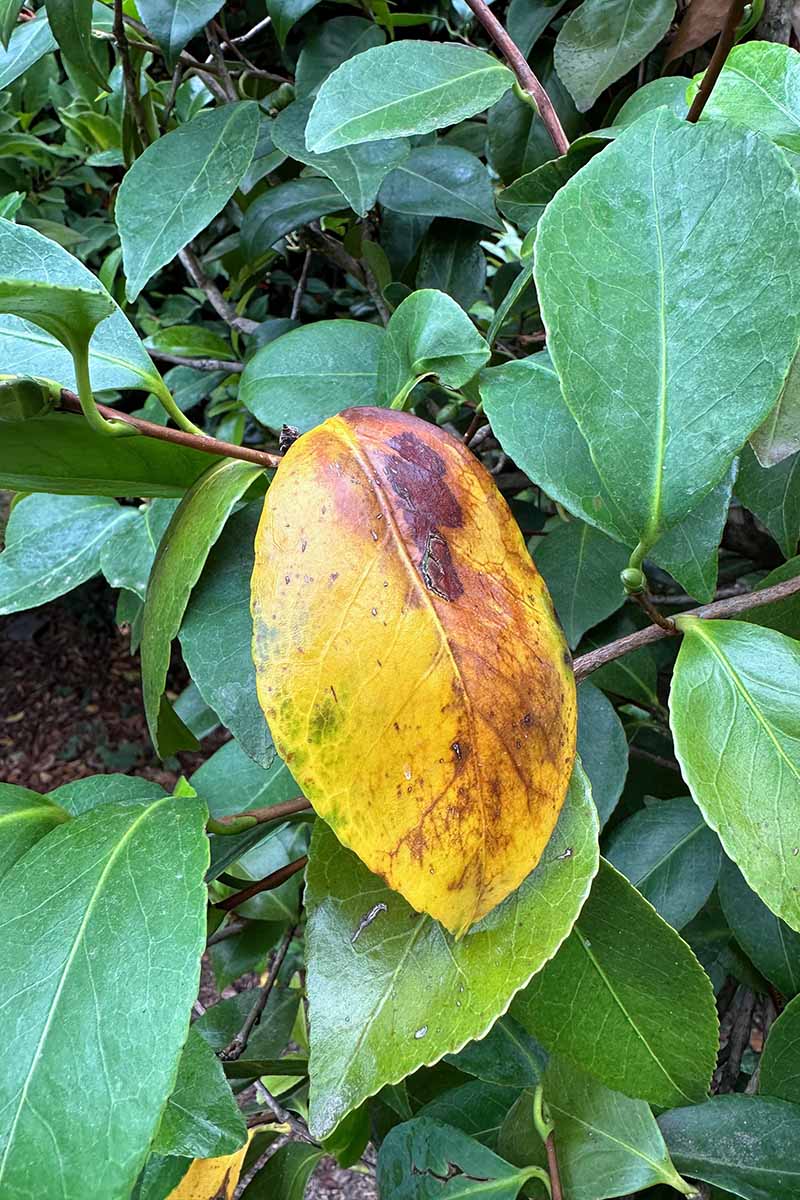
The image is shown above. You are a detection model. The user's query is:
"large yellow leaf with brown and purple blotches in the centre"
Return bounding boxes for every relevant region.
[252,408,576,936]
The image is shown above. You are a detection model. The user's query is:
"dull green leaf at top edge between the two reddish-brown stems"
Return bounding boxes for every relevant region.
[555,0,675,113]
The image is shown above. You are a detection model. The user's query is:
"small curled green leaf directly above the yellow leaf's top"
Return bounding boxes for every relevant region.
[378,289,492,404]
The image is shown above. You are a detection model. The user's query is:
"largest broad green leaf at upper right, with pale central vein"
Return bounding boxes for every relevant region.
[535,108,800,551]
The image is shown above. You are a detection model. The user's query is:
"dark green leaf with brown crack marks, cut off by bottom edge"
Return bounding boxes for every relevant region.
[378,1117,542,1200]
